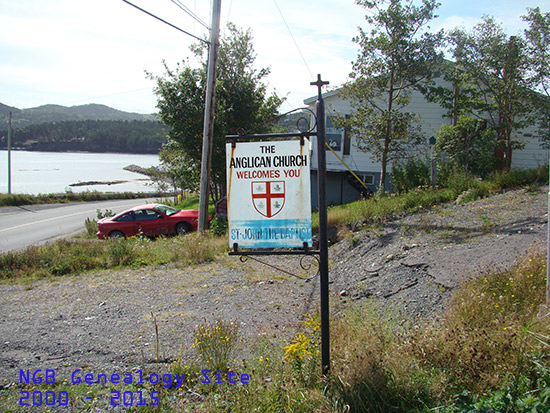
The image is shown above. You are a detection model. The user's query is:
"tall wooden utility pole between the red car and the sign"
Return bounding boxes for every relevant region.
[198,0,221,232]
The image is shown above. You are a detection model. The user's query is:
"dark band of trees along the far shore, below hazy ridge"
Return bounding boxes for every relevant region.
[0,120,168,154]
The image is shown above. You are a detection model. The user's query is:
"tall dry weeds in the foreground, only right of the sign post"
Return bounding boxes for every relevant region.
[324,254,550,411]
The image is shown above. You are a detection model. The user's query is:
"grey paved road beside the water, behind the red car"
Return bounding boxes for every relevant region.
[0,197,162,253]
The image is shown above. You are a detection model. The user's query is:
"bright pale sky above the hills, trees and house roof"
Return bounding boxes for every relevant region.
[0,0,550,113]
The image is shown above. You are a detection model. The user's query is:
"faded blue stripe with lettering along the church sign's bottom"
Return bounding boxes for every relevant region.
[229,219,312,248]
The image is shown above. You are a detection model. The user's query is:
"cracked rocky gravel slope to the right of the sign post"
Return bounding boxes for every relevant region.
[331,187,548,321]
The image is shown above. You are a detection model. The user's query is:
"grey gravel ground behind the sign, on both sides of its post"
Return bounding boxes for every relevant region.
[0,187,548,389]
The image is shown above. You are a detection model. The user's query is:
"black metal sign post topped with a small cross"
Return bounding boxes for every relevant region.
[311,75,330,375]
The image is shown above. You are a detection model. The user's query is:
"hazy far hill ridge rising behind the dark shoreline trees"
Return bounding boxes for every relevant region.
[0,103,155,129]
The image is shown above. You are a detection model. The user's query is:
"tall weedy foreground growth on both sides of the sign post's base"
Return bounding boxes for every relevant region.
[164,252,550,412]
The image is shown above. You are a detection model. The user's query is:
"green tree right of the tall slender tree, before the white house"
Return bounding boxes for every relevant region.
[451,16,533,170]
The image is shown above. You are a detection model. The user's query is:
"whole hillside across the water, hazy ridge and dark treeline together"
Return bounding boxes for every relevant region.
[0,103,168,153]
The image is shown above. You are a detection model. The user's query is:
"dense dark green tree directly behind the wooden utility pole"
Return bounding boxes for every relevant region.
[149,23,282,200]
